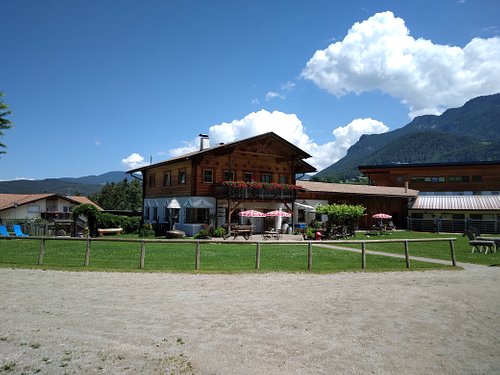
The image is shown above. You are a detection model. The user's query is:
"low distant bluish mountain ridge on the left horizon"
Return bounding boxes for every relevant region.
[0,172,131,196]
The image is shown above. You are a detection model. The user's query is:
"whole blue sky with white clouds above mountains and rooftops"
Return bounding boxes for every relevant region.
[0,0,500,180]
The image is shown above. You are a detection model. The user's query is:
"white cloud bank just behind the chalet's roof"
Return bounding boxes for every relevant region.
[165,109,389,171]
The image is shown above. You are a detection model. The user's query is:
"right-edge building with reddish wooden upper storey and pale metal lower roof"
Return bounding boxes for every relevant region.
[358,161,500,233]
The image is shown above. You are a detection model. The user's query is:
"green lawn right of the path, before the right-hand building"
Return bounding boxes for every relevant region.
[346,231,500,265]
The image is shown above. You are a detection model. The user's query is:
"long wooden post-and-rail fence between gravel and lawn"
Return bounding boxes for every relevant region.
[0,236,457,271]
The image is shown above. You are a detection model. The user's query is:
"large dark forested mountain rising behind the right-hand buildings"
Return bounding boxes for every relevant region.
[314,94,500,180]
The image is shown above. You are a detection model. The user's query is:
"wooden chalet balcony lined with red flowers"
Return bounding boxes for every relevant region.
[215,184,297,202]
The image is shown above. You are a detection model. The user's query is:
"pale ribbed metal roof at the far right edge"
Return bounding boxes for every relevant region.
[410,195,500,211]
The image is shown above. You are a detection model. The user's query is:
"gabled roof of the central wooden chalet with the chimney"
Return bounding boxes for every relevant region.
[127,132,316,174]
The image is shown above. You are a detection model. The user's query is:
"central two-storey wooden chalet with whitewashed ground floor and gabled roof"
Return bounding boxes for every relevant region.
[129,132,316,234]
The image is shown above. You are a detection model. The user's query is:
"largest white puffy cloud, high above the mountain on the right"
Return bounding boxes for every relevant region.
[301,12,500,117]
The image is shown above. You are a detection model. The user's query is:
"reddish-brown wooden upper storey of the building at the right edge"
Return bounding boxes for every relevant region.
[358,161,500,192]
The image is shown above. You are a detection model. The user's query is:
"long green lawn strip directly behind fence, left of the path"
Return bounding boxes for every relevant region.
[0,237,452,273]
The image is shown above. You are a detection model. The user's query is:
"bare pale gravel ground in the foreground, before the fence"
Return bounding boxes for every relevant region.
[0,267,500,374]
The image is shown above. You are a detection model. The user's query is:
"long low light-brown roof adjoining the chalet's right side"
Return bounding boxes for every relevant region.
[297,181,418,198]
